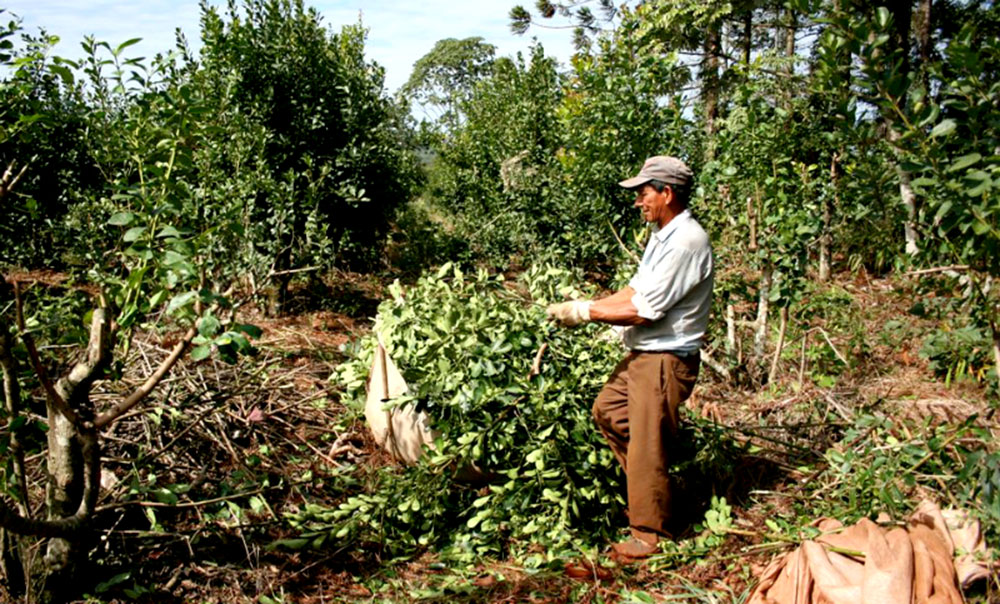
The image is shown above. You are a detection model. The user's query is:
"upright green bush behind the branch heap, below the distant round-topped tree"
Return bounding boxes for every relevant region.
[420,46,568,267]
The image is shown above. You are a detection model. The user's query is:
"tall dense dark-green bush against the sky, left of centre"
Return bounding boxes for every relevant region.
[199,0,417,295]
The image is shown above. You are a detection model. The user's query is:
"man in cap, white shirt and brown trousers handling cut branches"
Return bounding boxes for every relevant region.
[548,156,713,560]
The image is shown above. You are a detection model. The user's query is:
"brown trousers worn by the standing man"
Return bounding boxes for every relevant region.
[594,351,700,540]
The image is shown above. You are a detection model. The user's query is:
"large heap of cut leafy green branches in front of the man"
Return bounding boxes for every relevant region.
[286,265,624,559]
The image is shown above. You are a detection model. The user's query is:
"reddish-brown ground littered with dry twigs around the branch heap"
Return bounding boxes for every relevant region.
[3,275,987,604]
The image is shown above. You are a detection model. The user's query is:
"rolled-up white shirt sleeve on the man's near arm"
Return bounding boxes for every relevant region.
[629,248,710,321]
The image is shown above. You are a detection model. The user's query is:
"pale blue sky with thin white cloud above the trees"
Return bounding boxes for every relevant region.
[0,0,572,92]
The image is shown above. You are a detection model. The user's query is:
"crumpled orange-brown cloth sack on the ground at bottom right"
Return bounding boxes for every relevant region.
[749,501,990,604]
